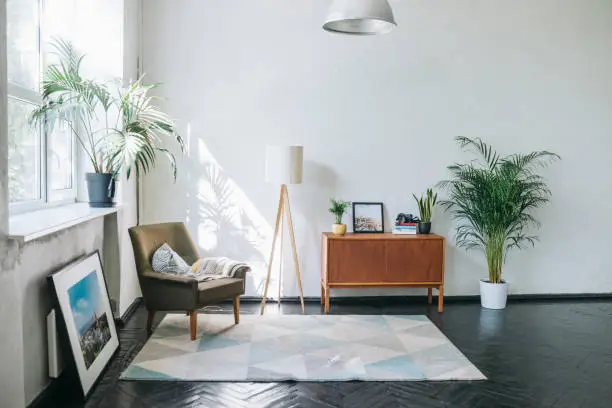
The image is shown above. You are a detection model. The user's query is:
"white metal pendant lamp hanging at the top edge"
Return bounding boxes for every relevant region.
[323,0,397,35]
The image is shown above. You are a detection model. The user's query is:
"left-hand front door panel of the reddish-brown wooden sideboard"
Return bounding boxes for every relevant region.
[327,240,385,283]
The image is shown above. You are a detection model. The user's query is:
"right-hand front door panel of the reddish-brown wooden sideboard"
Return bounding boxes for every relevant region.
[383,240,444,283]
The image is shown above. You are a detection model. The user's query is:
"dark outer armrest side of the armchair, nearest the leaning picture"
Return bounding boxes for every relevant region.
[140,270,198,311]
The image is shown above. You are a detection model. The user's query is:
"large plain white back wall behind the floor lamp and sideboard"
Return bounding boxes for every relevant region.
[143,0,612,296]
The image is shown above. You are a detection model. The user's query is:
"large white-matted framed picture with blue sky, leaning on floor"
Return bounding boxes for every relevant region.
[47,251,119,398]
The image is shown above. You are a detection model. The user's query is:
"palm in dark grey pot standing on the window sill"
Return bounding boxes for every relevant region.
[30,39,183,207]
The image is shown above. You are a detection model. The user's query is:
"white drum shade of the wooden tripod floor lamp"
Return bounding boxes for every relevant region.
[266,146,304,184]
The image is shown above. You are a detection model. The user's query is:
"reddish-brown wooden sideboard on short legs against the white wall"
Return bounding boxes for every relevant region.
[321,232,446,313]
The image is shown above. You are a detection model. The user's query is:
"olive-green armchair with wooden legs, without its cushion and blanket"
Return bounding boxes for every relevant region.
[129,222,246,340]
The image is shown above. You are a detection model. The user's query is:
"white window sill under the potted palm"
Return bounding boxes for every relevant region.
[8,203,119,244]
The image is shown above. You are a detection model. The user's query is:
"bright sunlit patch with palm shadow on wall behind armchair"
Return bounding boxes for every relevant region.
[184,135,275,295]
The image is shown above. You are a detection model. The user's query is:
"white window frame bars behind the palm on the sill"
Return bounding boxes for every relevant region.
[7,0,78,214]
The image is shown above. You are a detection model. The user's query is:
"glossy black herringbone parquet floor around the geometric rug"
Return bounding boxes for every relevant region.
[39,300,612,408]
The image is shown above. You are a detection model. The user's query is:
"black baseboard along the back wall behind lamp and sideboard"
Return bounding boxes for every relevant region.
[234,291,612,304]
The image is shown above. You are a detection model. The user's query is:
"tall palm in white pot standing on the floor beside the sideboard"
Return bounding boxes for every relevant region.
[439,136,560,309]
